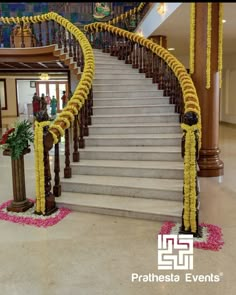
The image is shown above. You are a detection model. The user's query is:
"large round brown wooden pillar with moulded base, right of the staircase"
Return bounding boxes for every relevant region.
[192,3,224,177]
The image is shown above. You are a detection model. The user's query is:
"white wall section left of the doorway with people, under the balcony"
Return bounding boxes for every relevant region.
[17,80,36,115]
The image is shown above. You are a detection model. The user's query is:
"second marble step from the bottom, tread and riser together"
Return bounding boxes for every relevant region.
[61,175,183,201]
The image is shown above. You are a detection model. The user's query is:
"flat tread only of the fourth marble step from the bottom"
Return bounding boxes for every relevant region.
[79,146,181,153]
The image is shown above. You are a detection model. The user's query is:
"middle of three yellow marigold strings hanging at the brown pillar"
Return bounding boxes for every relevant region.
[206,3,212,89]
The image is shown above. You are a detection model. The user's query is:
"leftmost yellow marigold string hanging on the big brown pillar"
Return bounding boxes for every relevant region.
[189,3,196,74]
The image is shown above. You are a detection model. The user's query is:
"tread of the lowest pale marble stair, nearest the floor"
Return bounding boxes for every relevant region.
[57,192,182,217]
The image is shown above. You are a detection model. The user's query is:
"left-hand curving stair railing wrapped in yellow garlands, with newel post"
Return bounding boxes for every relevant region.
[0,12,94,215]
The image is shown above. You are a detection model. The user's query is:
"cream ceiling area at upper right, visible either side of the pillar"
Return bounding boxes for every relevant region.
[152,3,236,57]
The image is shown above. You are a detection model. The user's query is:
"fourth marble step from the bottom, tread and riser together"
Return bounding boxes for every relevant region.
[79,146,182,161]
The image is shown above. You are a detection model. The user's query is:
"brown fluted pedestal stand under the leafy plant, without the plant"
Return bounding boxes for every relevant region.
[3,148,34,212]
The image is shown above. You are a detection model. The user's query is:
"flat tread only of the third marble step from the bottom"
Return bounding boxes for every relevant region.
[71,160,184,170]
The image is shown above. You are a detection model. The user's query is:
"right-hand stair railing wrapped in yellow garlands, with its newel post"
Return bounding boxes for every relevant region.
[85,23,201,236]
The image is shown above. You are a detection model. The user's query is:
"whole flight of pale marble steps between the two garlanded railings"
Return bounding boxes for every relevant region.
[57,50,183,221]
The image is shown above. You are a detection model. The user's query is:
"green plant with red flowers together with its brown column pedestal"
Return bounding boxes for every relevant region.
[0,120,34,212]
